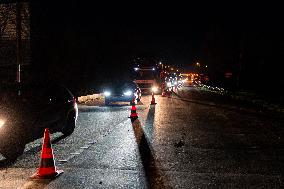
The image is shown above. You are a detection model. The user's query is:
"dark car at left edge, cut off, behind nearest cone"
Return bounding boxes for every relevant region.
[0,83,78,161]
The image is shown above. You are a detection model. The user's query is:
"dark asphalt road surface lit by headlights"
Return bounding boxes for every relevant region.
[0,86,284,188]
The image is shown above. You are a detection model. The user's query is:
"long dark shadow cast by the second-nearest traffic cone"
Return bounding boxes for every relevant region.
[132,115,165,188]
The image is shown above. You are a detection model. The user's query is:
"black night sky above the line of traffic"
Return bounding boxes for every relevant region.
[28,1,284,94]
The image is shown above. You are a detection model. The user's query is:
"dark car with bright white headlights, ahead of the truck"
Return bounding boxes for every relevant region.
[103,80,141,105]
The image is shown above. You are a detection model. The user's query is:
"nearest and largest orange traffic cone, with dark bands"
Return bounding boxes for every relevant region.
[31,128,63,179]
